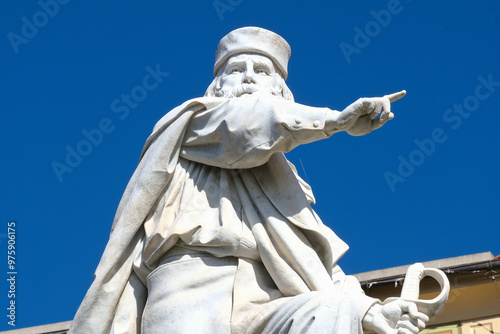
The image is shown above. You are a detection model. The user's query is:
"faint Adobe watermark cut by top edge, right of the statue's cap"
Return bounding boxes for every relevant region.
[339,0,411,64]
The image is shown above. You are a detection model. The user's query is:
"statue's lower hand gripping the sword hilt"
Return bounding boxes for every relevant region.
[363,299,429,334]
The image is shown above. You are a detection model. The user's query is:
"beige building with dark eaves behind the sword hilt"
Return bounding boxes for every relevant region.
[355,252,500,334]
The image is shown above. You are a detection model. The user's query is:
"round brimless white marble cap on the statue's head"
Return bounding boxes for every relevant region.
[214,27,291,79]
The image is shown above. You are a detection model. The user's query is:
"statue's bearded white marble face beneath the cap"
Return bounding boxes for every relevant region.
[220,54,281,97]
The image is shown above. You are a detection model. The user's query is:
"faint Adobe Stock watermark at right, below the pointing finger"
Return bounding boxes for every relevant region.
[384,73,500,192]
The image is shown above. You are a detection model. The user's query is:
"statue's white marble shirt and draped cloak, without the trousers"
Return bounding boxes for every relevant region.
[70,93,376,333]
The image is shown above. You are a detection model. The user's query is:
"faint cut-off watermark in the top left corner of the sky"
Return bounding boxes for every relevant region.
[7,0,70,54]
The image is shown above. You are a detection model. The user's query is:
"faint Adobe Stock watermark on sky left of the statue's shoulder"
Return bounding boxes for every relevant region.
[51,64,170,182]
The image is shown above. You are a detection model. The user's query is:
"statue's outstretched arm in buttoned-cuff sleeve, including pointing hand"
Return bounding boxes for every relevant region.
[180,91,406,168]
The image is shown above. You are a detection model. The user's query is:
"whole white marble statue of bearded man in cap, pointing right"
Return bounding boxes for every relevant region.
[70,27,428,334]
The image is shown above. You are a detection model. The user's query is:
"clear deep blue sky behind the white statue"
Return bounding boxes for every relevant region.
[0,0,500,330]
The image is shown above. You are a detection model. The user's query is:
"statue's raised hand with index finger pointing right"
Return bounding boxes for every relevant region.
[338,90,406,136]
